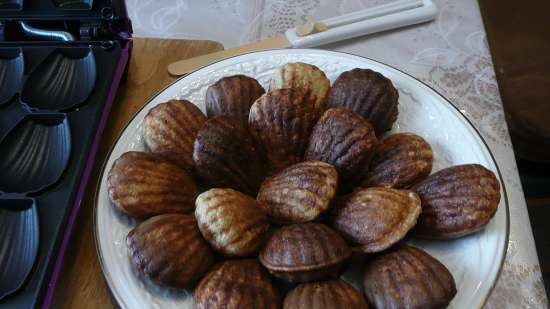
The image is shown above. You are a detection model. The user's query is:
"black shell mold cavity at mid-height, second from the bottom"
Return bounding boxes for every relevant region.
[0,114,71,193]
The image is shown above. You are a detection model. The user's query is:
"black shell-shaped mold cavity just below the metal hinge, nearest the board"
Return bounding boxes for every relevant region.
[21,48,97,110]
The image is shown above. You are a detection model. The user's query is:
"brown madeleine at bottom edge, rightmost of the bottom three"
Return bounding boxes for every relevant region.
[363,245,456,309]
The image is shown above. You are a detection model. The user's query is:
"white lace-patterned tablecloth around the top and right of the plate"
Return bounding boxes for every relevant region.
[126,0,548,309]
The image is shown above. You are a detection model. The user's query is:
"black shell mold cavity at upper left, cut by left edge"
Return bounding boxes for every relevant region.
[0,48,25,105]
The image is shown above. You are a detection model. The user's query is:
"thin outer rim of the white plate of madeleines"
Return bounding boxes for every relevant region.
[92,48,510,309]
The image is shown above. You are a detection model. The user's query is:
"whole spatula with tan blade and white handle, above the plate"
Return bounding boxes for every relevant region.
[168,0,437,75]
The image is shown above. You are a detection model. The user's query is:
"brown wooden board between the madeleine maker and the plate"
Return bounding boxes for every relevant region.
[51,39,223,309]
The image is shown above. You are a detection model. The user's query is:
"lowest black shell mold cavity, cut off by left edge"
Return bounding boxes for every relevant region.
[0,197,40,300]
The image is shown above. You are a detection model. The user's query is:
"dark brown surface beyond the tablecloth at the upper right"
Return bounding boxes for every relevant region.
[479,0,550,163]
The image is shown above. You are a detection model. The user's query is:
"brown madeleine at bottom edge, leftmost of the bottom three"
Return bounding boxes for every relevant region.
[195,259,281,309]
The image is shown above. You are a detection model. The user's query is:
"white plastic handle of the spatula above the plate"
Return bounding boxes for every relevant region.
[285,0,437,48]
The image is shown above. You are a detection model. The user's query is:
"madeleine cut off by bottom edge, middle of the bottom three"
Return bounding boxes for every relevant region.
[283,279,369,309]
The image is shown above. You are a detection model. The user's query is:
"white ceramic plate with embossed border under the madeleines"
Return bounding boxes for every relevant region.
[95,49,508,309]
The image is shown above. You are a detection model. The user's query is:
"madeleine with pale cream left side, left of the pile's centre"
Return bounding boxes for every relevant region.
[195,188,269,256]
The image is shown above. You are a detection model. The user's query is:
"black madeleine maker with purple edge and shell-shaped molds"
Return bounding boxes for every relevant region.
[0,0,132,309]
